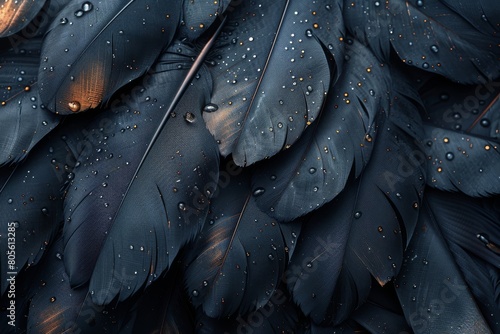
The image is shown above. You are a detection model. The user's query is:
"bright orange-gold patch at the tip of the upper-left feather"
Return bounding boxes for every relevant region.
[61,61,107,112]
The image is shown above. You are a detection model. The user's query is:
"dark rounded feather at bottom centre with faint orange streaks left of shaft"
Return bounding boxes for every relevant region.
[186,171,299,318]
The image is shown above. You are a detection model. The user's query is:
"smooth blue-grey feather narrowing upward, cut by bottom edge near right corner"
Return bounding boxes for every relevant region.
[396,192,490,333]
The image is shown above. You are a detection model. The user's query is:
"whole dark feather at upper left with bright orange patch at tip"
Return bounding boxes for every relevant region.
[39,0,181,114]
